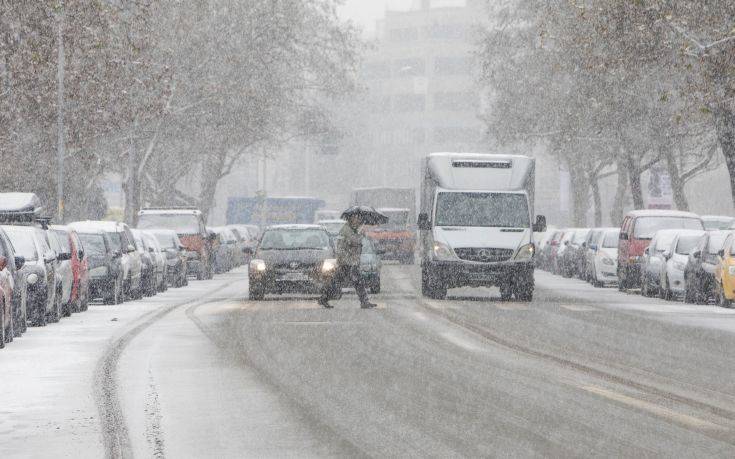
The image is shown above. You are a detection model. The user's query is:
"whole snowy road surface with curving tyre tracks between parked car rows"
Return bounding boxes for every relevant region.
[0,265,735,457]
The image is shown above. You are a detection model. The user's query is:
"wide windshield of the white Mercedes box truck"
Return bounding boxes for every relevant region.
[436,192,530,228]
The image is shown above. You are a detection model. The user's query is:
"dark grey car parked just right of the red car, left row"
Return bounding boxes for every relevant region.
[69,223,125,304]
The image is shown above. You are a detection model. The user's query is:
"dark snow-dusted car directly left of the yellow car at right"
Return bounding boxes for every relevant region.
[684,230,732,304]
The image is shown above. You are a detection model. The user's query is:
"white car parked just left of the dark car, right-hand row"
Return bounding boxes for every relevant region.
[659,230,704,300]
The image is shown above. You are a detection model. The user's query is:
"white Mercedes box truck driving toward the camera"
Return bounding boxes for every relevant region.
[418,153,546,301]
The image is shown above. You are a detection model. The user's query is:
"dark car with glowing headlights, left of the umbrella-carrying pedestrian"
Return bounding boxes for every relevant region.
[249,225,337,300]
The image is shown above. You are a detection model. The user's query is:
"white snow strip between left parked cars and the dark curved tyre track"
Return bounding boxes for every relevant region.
[0,279,233,458]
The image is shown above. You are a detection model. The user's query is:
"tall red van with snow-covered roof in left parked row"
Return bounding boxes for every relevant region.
[138,207,216,280]
